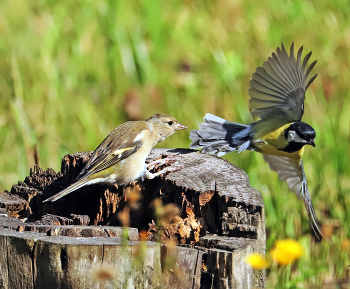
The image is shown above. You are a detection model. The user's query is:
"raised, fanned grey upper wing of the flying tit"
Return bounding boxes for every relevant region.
[248,43,317,123]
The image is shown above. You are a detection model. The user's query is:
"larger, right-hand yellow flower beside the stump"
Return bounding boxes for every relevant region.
[270,239,304,265]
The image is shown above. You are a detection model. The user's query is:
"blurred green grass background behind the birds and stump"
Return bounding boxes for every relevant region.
[0,0,350,288]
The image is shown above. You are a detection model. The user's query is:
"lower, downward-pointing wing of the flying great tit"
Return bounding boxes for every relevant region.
[264,154,323,239]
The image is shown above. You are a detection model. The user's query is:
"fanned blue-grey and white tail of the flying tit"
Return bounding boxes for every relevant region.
[190,113,251,156]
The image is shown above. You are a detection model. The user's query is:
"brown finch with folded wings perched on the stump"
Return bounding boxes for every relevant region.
[44,114,187,202]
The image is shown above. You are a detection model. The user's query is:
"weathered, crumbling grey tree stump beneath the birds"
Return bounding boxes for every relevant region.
[0,149,266,289]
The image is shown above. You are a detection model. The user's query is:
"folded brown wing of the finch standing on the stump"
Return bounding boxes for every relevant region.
[76,126,148,180]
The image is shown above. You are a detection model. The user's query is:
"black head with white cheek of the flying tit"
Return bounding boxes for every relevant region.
[285,121,316,147]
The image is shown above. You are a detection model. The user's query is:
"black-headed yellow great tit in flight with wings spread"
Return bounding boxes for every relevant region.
[190,43,322,239]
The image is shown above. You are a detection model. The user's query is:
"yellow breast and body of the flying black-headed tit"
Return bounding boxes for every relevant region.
[253,123,304,159]
